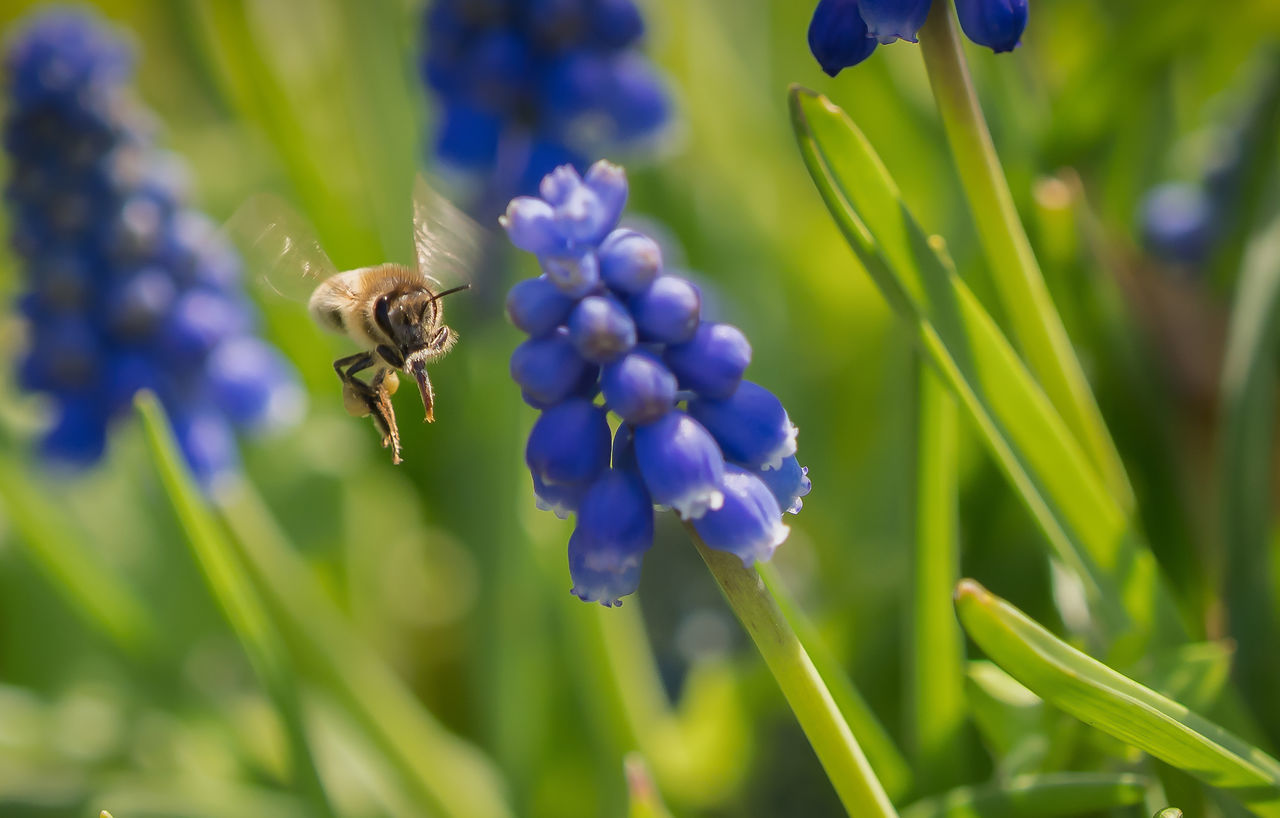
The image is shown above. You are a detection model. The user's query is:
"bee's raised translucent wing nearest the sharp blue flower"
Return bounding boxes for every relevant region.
[413,175,484,287]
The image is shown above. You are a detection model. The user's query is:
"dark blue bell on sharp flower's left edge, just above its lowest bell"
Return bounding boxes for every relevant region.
[525,398,612,485]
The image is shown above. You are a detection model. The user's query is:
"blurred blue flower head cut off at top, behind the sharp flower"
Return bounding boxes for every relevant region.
[422,0,668,209]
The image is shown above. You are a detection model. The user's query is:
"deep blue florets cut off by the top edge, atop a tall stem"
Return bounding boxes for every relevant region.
[809,0,1027,77]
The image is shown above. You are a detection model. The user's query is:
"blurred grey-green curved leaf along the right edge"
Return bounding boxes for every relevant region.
[1219,220,1280,742]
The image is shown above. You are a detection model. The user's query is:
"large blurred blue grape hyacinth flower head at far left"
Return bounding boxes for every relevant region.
[4,10,303,489]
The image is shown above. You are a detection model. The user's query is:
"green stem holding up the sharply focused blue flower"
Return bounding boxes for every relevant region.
[686,526,897,818]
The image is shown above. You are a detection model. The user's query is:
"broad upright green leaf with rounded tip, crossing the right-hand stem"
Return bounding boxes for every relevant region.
[791,88,1183,657]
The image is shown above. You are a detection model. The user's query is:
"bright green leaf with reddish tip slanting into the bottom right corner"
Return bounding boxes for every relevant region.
[956,580,1280,818]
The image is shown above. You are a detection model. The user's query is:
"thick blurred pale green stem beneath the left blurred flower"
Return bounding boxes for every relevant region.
[218,483,513,818]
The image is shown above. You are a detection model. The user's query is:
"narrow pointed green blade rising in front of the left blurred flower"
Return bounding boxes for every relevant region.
[134,393,337,817]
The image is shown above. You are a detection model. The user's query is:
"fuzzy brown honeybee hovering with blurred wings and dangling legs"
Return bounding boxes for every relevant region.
[232,178,479,463]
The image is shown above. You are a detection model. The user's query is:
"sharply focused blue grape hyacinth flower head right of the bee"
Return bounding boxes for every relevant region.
[500,161,809,605]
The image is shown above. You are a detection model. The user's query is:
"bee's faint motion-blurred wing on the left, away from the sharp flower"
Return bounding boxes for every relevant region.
[225,193,338,303]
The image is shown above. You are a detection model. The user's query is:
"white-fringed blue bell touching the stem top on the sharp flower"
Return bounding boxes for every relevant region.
[694,466,790,567]
